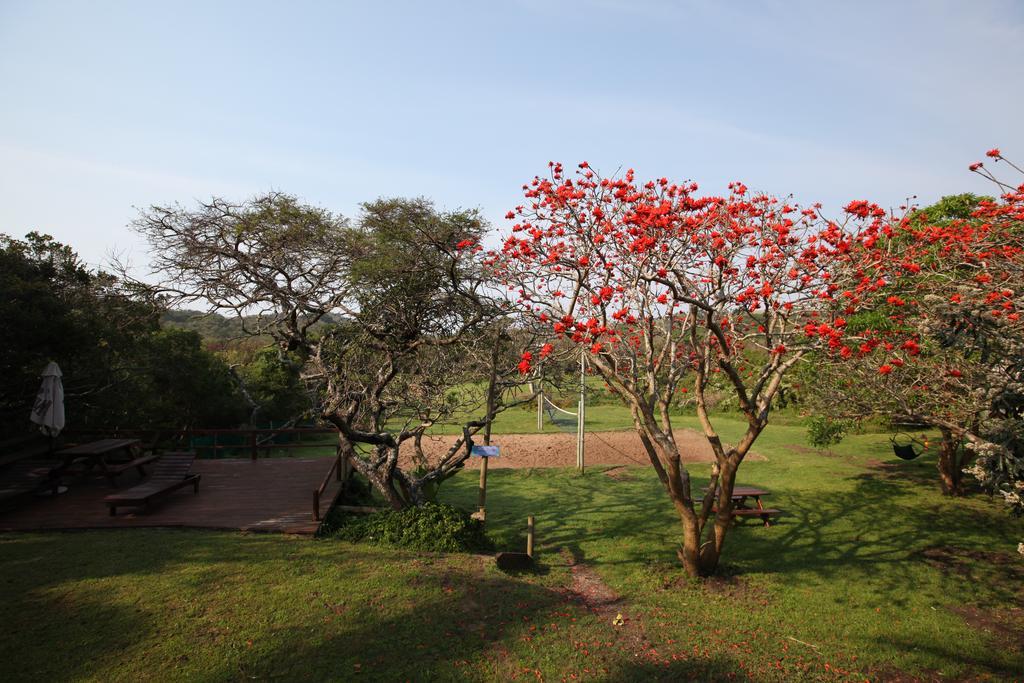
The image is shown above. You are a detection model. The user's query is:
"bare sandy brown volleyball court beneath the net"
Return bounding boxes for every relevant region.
[401,429,764,469]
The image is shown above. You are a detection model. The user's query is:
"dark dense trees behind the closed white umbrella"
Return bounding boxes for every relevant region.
[0,232,242,433]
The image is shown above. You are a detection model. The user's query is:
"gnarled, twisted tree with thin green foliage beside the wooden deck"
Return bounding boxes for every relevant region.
[135,193,528,509]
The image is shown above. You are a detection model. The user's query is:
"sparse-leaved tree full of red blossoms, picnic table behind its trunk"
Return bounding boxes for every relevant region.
[486,163,886,575]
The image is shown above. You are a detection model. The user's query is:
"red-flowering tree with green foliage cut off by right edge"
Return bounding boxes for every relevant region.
[802,150,1024,496]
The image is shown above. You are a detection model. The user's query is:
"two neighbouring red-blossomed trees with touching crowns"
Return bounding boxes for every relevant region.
[486,156,1024,575]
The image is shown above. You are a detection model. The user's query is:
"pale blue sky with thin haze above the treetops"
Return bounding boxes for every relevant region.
[0,0,1024,273]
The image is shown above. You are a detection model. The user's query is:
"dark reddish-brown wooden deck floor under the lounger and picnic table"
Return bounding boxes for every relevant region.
[0,458,338,535]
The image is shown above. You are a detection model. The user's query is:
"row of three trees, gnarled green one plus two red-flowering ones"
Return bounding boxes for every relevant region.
[37,151,1007,575]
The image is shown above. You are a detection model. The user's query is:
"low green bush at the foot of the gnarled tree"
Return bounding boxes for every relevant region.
[328,503,494,553]
